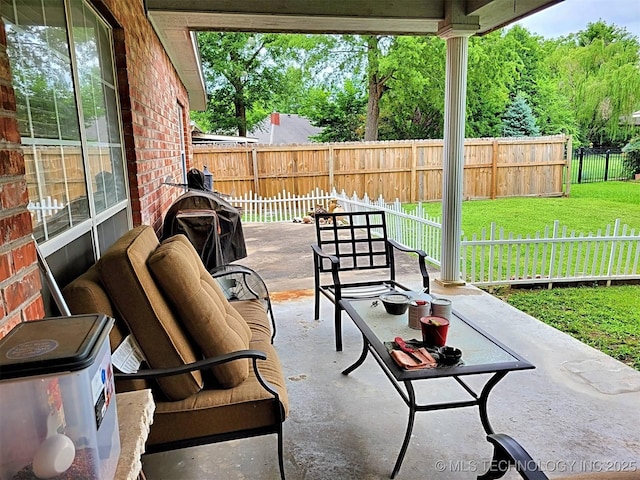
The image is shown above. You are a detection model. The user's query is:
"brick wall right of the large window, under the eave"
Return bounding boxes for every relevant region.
[96,0,191,231]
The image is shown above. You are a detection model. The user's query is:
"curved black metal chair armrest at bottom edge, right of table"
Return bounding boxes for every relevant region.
[478,433,549,480]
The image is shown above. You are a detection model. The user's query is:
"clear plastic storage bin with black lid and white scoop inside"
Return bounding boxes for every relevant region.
[0,315,120,480]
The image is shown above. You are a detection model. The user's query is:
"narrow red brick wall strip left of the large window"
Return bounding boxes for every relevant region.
[0,22,44,338]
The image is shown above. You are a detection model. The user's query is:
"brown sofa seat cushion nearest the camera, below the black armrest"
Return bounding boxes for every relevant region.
[147,341,288,445]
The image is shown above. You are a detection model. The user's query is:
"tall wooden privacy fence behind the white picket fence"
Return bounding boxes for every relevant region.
[193,135,571,202]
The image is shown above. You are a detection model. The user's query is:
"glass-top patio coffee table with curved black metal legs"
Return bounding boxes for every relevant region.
[340,294,535,478]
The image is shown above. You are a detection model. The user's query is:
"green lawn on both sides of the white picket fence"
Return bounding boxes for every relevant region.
[404,182,640,370]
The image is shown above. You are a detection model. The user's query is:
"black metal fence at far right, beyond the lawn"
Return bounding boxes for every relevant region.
[571,147,632,183]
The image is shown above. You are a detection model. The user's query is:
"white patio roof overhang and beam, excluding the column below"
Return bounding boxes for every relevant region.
[146,0,562,110]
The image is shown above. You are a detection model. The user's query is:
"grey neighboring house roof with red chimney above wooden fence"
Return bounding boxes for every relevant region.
[249,113,322,145]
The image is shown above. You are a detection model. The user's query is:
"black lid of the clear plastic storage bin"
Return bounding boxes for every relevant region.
[0,314,114,380]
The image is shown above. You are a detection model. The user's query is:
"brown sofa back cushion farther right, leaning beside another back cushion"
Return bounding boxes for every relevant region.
[148,239,251,388]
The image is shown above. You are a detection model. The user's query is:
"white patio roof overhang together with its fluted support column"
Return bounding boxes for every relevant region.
[145,0,562,285]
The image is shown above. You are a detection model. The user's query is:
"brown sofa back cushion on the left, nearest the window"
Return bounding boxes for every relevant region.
[96,225,203,400]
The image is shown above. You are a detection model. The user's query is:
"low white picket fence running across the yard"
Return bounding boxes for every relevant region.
[229,189,640,286]
